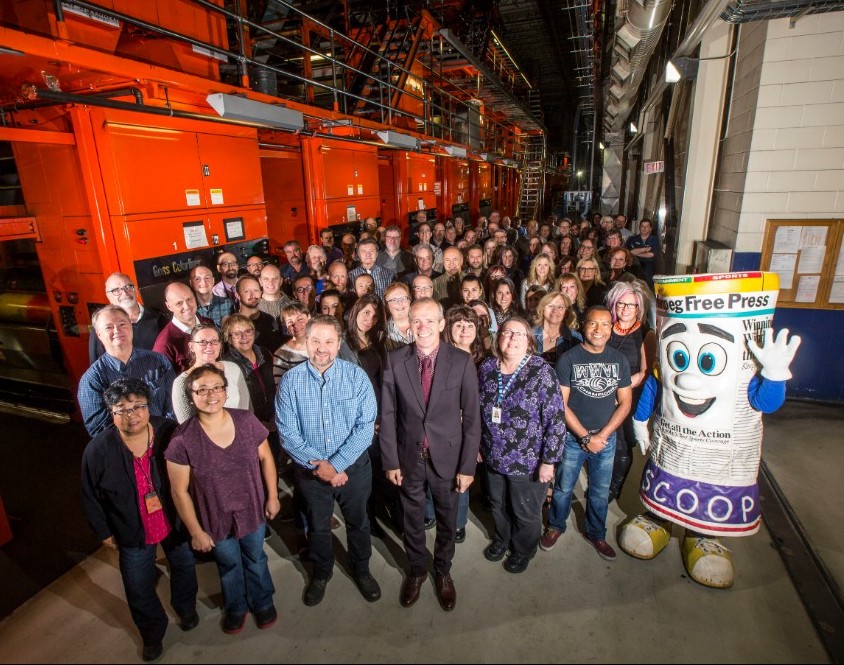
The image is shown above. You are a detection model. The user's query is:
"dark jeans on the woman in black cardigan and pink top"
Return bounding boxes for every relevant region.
[119,531,197,645]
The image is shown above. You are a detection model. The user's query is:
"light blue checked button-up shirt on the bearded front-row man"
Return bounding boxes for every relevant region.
[275,358,378,473]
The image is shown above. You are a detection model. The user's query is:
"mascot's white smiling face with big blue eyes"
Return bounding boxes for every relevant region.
[659,323,743,425]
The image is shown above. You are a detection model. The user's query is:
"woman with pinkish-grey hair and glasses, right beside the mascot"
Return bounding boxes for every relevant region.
[607,280,656,501]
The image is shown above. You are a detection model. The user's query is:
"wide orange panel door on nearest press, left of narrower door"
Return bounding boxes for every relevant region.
[98,122,207,215]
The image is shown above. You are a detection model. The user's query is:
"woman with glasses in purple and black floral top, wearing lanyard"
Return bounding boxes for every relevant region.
[479,317,566,573]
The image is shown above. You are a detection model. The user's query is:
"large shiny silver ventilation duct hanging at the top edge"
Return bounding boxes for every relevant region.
[604,0,673,132]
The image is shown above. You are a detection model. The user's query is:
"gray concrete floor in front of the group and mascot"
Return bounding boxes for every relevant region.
[0,403,844,663]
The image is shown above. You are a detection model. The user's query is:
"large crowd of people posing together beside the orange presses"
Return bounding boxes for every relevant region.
[79,212,659,661]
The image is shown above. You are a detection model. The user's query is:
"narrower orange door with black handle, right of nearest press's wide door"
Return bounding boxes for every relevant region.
[197,131,264,208]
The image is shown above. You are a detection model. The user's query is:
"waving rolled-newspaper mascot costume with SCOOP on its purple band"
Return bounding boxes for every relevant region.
[619,272,800,588]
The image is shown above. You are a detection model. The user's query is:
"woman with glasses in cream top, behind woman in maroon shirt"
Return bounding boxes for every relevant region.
[172,323,252,423]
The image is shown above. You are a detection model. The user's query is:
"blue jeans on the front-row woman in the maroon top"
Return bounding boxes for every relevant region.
[214,524,275,615]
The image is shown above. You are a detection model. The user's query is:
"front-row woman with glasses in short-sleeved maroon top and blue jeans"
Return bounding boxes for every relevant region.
[165,365,279,635]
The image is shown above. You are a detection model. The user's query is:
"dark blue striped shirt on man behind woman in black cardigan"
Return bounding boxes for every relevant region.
[77,349,176,436]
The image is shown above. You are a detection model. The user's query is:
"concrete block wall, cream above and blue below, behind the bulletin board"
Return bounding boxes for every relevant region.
[709,11,844,402]
